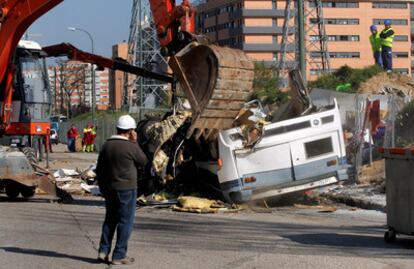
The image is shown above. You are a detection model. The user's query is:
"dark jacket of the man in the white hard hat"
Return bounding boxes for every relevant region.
[96,136,147,195]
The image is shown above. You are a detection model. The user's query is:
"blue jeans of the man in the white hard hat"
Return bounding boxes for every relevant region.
[99,187,137,260]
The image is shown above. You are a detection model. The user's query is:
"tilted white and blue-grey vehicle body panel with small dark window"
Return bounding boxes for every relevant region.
[217,100,348,202]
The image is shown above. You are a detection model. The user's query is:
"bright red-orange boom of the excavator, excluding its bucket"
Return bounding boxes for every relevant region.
[0,0,191,131]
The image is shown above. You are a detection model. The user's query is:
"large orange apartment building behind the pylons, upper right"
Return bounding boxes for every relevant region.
[196,0,411,80]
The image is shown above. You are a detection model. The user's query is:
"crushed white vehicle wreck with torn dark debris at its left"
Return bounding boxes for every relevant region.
[138,70,348,202]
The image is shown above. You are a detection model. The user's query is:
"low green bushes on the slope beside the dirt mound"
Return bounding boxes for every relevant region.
[308,65,383,92]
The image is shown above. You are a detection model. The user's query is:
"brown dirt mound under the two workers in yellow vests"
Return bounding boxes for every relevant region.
[358,72,414,96]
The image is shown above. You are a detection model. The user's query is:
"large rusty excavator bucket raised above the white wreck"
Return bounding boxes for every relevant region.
[169,45,254,135]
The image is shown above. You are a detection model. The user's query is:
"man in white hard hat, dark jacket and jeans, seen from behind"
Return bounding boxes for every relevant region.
[96,115,147,265]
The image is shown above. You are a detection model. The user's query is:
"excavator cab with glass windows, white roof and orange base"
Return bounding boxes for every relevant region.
[0,40,51,155]
